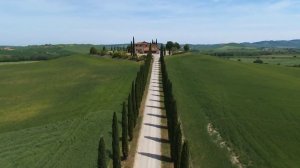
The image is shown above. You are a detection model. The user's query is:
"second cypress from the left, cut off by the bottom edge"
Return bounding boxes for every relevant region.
[112,112,121,168]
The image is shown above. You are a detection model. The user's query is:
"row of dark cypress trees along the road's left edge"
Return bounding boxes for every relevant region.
[98,54,152,168]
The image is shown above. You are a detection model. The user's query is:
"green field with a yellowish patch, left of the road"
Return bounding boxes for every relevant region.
[0,56,138,168]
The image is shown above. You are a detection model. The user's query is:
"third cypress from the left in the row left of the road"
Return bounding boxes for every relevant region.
[122,102,129,160]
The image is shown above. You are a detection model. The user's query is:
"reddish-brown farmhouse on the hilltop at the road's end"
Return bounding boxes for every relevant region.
[135,41,159,54]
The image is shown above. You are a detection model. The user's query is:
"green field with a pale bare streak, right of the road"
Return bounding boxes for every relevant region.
[166,54,300,168]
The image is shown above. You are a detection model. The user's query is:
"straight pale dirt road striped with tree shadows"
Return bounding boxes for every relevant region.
[134,55,167,168]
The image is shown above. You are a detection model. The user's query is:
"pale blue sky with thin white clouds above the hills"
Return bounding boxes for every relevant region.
[0,0,300,45]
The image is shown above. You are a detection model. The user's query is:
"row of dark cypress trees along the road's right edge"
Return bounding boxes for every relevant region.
[160,45,190,168]
